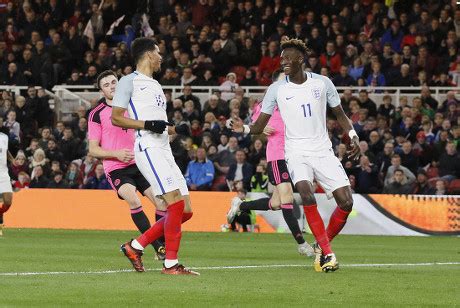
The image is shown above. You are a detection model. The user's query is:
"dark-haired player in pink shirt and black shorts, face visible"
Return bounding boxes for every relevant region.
[88,70,166,260]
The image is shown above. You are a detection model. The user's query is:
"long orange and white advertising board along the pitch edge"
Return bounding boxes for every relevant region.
[5,189,460,235]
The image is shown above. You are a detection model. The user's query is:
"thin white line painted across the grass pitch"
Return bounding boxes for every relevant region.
[0,262,460,277]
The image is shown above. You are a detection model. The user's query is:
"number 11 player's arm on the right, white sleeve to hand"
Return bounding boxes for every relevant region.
[325,77,359,160]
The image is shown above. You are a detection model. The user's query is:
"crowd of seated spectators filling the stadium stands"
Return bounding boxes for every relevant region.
[0,0,460,194]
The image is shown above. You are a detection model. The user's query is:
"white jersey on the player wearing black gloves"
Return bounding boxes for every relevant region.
[112,71,171,151]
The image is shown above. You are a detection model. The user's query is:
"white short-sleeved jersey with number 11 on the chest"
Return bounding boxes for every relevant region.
[262,72,340,156]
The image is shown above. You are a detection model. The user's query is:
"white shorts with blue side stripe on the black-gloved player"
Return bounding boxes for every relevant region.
[134,148,189,196]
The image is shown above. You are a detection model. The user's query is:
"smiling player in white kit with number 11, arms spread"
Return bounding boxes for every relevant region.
[230,39,359,272]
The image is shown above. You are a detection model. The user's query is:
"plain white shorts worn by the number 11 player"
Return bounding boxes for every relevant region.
[286,152,350,198]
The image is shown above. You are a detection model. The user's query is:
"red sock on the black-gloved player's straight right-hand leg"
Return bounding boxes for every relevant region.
[164,200,185,260]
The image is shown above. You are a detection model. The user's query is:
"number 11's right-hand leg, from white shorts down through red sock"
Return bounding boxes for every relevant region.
[315,154,353,241]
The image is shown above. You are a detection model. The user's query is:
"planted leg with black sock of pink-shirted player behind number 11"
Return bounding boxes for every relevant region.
[276,182,314,256]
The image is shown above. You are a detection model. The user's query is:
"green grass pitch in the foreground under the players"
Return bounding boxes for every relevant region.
[0,229,460,307]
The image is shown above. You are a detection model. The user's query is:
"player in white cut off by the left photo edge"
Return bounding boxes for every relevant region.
[0,125,13,236]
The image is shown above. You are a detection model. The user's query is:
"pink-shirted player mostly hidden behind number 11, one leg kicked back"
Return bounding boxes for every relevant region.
[227,100,314,256]
